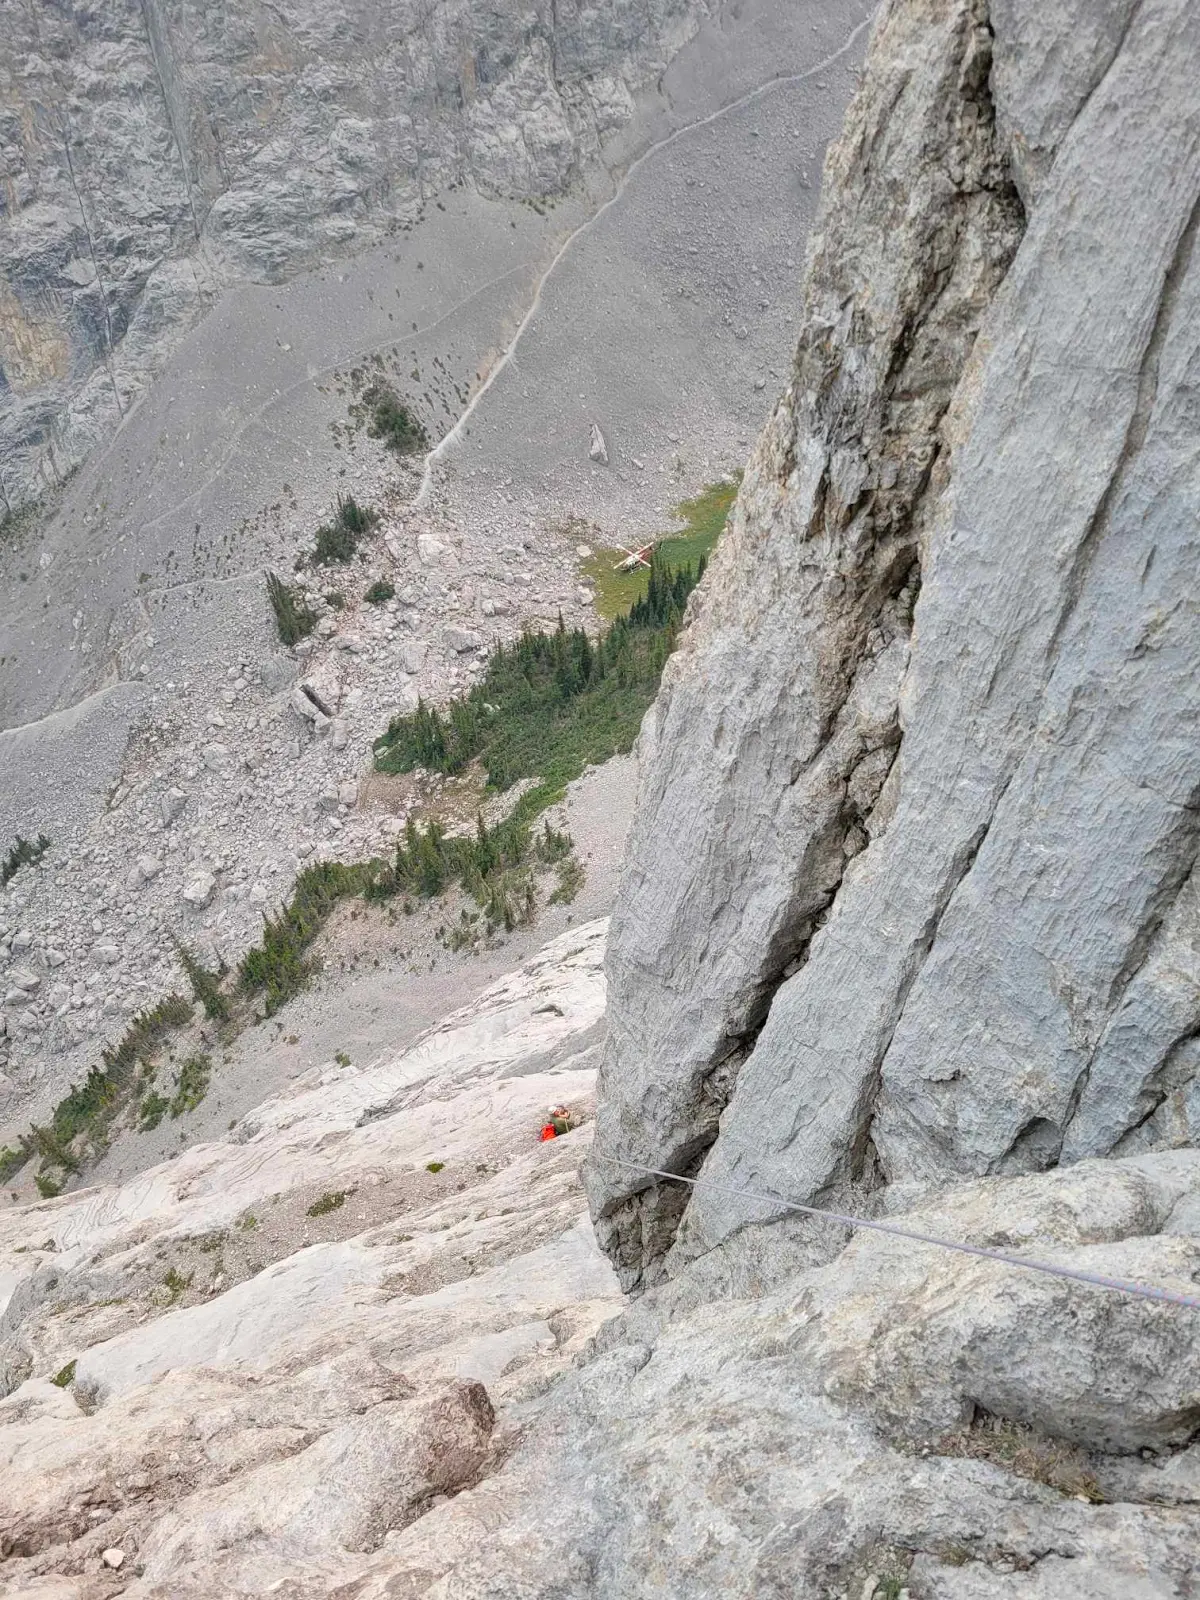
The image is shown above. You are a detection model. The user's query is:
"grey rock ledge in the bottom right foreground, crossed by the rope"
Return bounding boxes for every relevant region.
[195,1152,1200,1600]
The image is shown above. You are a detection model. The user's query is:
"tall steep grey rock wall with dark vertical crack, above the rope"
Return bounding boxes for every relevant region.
[590,0,1200,1283]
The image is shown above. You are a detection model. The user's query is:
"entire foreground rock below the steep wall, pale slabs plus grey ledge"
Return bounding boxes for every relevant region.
[9,953,1200,1600]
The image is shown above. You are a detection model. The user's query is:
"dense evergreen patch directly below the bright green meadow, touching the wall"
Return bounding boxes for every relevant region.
[376,557,704,789]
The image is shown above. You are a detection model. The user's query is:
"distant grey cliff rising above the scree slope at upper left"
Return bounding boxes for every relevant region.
[0,0,710,515]
